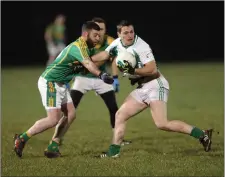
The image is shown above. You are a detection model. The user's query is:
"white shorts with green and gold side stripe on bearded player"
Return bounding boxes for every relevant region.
[38,77,72,109]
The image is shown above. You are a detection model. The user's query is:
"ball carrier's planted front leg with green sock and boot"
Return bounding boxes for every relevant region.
[100,90,147,158]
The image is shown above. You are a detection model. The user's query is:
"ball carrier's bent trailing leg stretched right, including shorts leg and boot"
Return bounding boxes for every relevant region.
[149,78,211,151]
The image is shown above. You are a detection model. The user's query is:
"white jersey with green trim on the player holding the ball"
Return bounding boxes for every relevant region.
[105,35,155,68]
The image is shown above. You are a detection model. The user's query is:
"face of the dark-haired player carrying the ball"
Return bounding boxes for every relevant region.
[118,25,135,46]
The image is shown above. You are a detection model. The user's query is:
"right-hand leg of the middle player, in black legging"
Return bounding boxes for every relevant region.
[97,79,131,146]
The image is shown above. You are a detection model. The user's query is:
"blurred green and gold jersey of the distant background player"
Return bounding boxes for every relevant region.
[46,24,66,44]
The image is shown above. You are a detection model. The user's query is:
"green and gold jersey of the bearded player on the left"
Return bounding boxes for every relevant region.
[41,37,93,83]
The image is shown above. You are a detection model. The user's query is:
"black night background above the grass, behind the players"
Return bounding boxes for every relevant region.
[1,1,224,66]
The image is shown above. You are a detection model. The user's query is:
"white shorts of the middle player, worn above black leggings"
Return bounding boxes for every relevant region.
[70,76,113,95]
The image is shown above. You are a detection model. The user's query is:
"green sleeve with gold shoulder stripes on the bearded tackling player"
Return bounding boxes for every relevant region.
[70,42,89,62]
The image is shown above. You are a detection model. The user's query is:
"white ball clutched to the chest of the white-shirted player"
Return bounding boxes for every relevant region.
[116,51,137,68]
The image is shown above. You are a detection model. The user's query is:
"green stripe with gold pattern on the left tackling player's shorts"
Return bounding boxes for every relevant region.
[46,82,56,107]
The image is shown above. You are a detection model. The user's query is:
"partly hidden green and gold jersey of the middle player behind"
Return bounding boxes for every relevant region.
[76,35,114,77]
